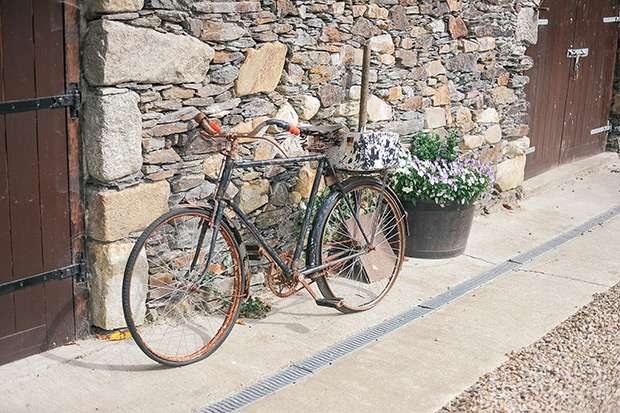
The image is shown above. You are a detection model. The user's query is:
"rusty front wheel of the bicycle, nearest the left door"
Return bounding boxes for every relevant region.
[122,208,245,366]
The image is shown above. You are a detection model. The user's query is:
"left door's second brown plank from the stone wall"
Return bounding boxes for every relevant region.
[1,2,45,332]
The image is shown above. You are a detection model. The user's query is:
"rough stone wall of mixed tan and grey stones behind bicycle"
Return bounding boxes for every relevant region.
[82,0,537,329]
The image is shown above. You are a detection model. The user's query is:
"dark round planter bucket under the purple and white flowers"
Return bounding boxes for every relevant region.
[403,201,475,259]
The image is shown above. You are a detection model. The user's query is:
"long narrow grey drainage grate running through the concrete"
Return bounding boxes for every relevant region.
[198,205,620,413]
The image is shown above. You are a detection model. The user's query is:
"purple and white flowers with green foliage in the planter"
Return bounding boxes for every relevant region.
[390,132,495,206]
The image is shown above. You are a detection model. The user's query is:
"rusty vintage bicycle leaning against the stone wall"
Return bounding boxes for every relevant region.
[122,113,407,366]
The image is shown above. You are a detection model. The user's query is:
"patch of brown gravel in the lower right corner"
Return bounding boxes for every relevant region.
[440,278,620,413]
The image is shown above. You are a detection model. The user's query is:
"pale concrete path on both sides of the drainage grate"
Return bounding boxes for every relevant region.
[0,154,620,412]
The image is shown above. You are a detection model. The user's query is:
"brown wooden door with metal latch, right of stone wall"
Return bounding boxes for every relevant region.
[526,0,618,178]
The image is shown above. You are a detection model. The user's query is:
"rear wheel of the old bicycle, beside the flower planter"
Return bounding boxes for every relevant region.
[309,177,405,313]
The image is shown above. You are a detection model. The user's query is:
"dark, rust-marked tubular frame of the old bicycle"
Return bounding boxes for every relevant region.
[203,154,387,286]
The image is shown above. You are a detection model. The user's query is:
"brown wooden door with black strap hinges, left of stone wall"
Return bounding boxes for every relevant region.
[0,0,81,364]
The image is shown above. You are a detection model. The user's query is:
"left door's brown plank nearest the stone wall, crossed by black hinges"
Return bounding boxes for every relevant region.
[33,0,75,347]
